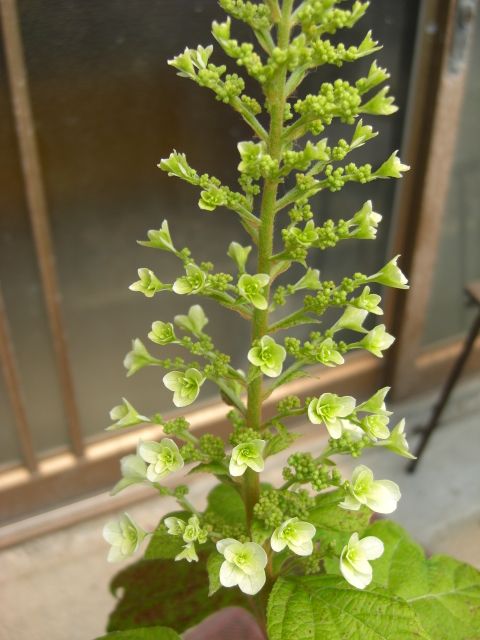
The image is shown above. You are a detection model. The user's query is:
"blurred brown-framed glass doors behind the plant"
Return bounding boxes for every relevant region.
[0,0,480,638]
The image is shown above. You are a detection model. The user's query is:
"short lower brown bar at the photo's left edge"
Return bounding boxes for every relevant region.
[0,289,38,473]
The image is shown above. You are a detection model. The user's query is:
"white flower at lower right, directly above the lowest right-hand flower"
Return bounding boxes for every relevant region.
[340,464,401,513]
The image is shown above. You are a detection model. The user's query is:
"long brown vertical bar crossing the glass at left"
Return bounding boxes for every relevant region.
[0,0,84,456]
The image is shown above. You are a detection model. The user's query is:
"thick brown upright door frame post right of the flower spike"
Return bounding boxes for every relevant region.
[387,0,480,398]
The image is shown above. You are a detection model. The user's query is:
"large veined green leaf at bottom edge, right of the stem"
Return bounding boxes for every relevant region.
[267,575,430,640]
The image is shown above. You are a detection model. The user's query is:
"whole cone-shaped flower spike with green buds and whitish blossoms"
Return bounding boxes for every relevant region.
[105,0,420,640]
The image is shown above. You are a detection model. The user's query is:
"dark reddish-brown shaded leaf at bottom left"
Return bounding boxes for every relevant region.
[107,553,247,640]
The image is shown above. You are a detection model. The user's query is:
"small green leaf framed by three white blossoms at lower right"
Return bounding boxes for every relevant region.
[308,490,372,552]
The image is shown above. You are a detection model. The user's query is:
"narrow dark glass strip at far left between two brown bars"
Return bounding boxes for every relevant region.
[0,38,67,459]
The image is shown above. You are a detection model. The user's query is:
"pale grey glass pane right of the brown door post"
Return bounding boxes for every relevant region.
[424,16,480,344]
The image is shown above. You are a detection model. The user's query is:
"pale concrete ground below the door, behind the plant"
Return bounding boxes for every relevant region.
[0,377,480,640]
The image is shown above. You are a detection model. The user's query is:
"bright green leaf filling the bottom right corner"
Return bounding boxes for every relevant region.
[365,520,480,640]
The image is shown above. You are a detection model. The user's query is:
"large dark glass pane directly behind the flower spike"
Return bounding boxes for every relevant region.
[19,0,417,435]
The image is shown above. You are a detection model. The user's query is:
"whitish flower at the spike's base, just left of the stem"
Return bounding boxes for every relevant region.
[217,538,267,596]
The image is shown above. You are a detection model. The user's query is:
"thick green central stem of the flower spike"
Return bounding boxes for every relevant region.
[244,0,293,529]
